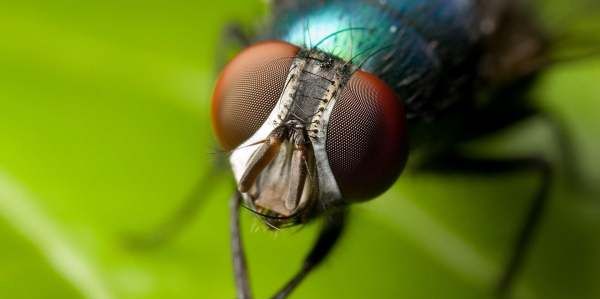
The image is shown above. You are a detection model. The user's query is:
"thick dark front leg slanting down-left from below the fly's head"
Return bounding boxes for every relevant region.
[272,209,347,299]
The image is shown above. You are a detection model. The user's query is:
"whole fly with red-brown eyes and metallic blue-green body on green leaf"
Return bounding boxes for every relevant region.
[135,0,592,299]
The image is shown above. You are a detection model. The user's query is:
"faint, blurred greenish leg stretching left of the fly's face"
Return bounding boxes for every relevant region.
[128,154,225,249]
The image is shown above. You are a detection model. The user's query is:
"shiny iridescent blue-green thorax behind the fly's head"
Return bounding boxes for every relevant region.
[267,0,478,119]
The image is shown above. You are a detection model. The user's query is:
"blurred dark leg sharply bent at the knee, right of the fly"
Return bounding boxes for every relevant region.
[421,152,552,298]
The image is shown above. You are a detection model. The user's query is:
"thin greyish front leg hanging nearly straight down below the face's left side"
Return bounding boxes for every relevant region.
[229,191,252,299]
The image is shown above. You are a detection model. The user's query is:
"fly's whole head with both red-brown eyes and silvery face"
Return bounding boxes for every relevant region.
[212,41,407,227]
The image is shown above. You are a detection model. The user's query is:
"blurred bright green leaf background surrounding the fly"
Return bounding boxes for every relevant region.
[0,0,600,299]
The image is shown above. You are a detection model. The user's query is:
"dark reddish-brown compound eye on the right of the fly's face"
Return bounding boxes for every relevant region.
[325,71,408,201]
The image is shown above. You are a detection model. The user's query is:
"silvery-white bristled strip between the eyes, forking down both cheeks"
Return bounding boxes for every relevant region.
[229,50,351,216]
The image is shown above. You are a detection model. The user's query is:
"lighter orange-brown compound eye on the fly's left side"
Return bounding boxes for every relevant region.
[212,41,299,150]
